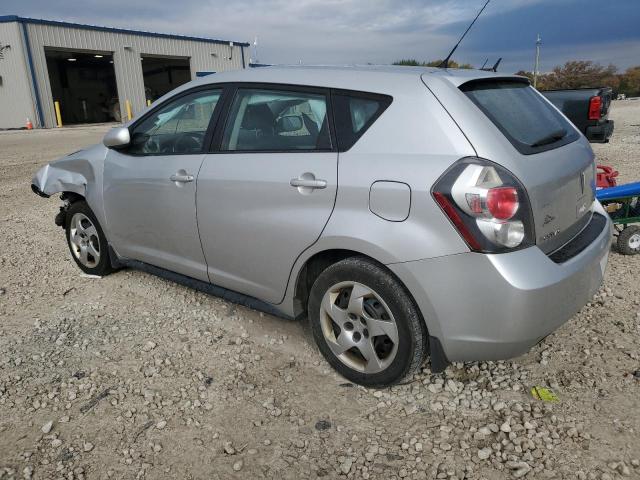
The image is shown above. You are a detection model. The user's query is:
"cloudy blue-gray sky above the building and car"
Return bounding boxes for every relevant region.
[0,0,640,72]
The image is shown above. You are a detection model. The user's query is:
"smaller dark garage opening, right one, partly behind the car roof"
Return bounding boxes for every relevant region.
[141,55,191,102]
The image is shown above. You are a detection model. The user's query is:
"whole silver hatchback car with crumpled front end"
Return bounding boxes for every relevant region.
[32,67,611,386]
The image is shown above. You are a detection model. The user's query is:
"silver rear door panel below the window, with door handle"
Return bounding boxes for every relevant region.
[196,152,338,303]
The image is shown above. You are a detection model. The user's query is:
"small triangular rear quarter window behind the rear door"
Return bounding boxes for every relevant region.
[333,91,392,152]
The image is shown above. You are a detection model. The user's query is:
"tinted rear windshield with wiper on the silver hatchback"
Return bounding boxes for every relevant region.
[460,80,579,155]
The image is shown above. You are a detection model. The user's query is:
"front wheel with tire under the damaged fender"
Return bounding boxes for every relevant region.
[65,201,113,277]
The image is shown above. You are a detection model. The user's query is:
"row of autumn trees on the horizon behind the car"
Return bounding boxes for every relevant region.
[394,59,640,97]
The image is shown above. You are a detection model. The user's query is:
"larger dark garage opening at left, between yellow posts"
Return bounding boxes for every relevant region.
[45,48,120,125]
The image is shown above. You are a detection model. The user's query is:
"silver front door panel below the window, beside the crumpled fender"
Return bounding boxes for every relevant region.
[103,149,209,281]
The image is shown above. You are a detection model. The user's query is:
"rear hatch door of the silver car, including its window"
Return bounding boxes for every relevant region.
[423,76,595,253]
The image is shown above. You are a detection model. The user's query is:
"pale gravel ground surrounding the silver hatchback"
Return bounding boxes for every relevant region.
[0,101,640,480]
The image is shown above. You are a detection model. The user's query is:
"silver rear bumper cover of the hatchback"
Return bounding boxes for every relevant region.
[388,204,612,361]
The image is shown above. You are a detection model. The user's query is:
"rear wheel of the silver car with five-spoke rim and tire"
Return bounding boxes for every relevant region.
[308,257,428,387]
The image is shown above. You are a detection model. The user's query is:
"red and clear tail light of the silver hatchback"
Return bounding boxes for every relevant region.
[432,158,535,253]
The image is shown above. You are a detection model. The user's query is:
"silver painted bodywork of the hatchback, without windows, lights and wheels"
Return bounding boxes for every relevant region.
[33,67,611,360]
